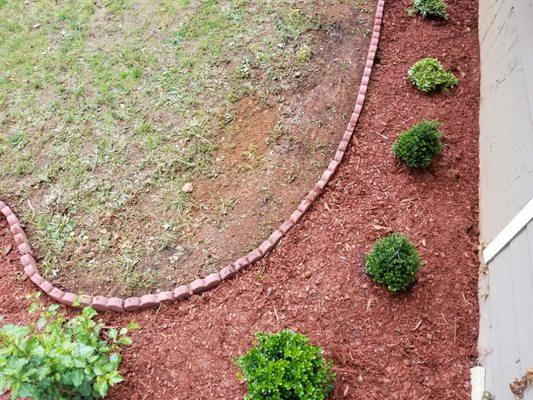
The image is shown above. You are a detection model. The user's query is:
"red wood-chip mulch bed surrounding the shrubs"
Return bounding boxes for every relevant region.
[0,0,479,400]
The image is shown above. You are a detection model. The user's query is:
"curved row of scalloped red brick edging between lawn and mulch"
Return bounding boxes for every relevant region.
[0,0,385,312]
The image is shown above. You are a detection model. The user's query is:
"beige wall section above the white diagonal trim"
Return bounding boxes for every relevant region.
[479,0,533,242]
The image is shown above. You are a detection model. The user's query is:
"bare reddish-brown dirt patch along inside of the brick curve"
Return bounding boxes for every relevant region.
[151,6,374,288]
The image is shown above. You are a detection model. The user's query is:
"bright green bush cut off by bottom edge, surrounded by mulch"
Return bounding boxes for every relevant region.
[237,329,335,400]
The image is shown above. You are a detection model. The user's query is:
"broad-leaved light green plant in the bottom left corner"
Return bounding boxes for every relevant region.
[0,304,135,400]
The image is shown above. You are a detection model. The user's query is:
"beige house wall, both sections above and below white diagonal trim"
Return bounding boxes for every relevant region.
[479,0,533,400]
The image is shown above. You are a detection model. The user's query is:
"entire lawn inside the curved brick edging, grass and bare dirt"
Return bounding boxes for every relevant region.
[0,0,374,296]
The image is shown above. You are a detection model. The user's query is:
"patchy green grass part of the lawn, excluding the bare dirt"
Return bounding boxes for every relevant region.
[0,0,374,291]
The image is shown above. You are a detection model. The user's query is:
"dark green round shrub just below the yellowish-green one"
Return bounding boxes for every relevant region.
[392,120,444,168]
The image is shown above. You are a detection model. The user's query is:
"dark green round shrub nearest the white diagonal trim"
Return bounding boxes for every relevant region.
[365,233,420,292]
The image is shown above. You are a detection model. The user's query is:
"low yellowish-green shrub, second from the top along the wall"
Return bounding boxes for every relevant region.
[408,57,459,93]
